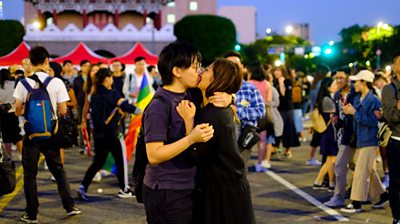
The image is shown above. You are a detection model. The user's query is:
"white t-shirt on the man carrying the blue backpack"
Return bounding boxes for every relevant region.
[13,72,69,114]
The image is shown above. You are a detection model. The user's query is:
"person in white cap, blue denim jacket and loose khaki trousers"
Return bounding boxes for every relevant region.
[341,70,387,213]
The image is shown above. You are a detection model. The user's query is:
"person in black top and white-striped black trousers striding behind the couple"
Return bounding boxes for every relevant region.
[77,68,141,200]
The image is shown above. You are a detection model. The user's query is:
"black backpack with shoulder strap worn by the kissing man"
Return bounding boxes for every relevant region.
[132,95,171,203]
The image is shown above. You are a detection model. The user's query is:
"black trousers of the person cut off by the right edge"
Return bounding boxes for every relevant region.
[386,139,400,219]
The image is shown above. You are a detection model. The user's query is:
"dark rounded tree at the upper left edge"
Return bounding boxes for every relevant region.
[0,20,25,56]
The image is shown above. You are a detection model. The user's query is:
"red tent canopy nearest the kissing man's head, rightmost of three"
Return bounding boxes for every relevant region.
[110,42,158,65]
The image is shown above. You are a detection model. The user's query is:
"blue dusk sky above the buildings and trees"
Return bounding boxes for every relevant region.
[3,0,400,44]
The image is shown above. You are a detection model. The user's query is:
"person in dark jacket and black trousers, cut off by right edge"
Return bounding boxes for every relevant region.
[382,53,400,224]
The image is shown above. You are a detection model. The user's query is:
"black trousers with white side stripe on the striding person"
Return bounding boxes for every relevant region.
[81,134,128,190]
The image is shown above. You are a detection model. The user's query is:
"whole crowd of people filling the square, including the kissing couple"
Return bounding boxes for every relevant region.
[0,42,400,223]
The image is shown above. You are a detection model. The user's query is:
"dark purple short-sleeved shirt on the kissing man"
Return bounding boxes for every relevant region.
[143,88,196,189]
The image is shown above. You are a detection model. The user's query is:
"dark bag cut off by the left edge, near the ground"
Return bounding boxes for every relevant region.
[0,144,16,197]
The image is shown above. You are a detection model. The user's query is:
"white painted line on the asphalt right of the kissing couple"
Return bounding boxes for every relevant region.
[265,171,349,222]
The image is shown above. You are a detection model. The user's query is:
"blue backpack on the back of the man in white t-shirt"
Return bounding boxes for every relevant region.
[21,75,54,141]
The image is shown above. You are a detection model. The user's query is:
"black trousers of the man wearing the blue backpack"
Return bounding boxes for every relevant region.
[22,138,74,217]
